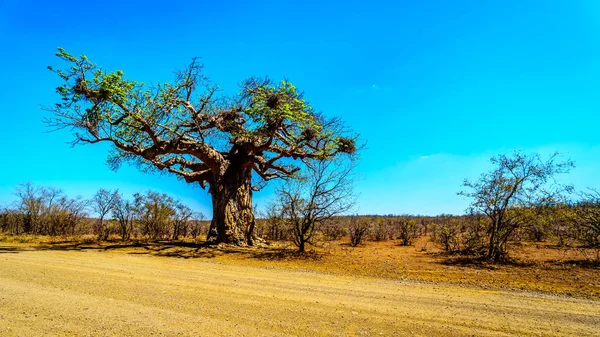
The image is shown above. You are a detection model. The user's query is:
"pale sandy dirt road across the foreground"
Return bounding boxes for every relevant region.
[0,246,600,336]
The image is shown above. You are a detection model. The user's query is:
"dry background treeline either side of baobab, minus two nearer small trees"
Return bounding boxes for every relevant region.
[0,183,600,262]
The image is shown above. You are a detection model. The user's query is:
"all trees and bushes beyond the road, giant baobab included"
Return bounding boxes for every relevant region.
[24,48,600,262]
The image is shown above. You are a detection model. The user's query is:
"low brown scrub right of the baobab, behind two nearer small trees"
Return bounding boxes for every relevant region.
[256,209,600,251]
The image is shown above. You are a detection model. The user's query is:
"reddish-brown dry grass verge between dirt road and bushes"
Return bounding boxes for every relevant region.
[0,237,600,299]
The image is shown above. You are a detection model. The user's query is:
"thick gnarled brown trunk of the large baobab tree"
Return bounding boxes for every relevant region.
[207,165,254,246]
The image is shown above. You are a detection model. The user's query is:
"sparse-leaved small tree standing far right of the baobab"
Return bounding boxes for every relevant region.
[459,152,574,261]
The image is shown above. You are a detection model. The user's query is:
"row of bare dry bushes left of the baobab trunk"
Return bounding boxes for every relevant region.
[0,183,208,240]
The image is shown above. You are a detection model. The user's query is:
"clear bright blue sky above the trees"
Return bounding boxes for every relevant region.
[0,0,600,214]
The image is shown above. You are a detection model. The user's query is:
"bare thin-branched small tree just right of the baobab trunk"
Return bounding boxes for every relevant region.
[277,160,355,253]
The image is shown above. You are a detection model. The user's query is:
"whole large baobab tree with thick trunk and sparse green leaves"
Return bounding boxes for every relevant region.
[46,48,357,245]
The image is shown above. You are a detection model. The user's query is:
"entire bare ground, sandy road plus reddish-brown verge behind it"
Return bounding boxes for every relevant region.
[0,238,600,336]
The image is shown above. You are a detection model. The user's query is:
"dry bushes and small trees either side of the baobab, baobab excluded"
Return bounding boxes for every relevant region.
[0,152,600,267]
